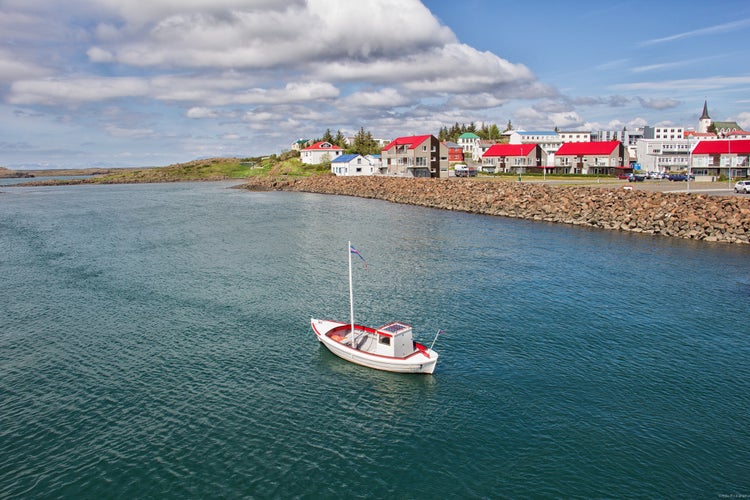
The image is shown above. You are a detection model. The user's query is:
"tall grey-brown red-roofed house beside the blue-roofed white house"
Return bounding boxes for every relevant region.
[381,135,448,177]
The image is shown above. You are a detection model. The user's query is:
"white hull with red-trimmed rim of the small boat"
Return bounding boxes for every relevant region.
[310,318,438,374]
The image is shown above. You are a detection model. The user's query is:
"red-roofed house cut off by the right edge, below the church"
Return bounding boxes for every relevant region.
[690,139,750,179]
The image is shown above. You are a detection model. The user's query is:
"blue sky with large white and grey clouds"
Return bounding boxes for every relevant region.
[0,0,750,169]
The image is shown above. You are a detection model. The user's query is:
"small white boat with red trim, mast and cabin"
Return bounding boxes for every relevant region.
[310,243,441,373]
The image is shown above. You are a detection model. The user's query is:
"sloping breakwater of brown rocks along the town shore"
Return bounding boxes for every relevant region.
[243,176,750,244]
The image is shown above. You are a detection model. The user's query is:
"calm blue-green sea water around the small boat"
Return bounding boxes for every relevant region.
[0,183,750,499]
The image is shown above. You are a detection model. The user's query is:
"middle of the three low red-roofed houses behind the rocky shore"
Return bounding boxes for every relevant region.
[555,141,632,175]
